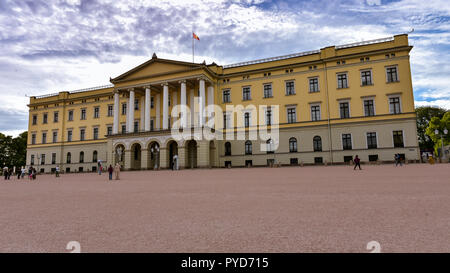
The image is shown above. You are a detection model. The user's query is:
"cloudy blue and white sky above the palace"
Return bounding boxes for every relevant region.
[0,0,450,136]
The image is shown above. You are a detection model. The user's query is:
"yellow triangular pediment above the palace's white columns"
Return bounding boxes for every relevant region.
[111,57,202,83]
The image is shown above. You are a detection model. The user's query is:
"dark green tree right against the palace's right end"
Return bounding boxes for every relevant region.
[416,106,447,150]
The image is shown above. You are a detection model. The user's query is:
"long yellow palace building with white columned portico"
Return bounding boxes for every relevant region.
[27,34,419,172]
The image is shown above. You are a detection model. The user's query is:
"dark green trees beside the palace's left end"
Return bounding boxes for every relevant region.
[0,132,28,167]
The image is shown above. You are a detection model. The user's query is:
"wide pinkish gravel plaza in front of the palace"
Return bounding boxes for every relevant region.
[0,164,450,252]
